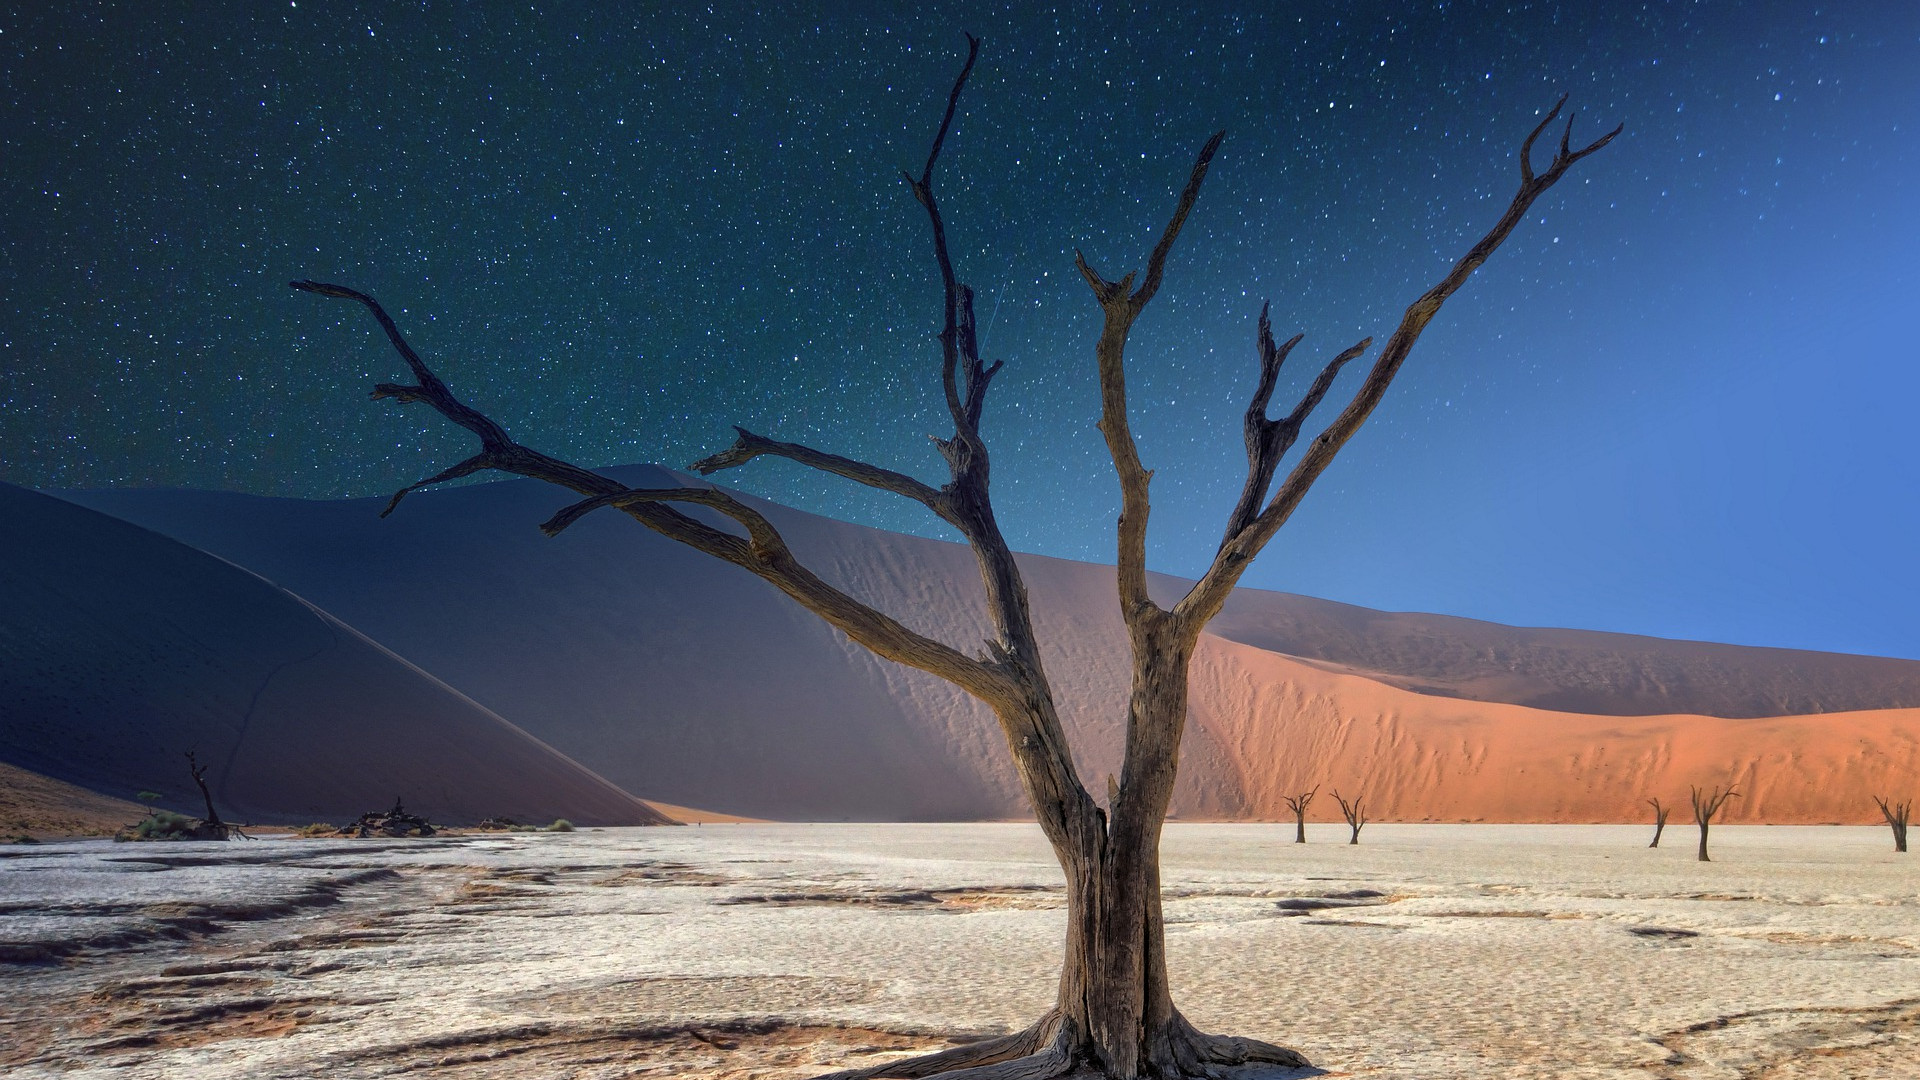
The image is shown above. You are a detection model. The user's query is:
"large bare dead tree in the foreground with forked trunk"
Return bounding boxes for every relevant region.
[292,37,1619,1080]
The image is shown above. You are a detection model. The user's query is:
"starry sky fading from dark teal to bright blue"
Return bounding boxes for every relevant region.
[0,0,1920,657]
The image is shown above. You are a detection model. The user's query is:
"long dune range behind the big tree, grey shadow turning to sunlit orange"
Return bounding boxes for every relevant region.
[52,465,1920,821]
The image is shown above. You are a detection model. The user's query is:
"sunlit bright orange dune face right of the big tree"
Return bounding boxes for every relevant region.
[1177,636,1920,824]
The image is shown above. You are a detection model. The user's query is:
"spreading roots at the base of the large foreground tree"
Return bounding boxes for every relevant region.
[818,1011,1309,1080]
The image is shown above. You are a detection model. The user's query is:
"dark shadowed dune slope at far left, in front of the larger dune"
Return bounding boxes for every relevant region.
[0,484,666,824]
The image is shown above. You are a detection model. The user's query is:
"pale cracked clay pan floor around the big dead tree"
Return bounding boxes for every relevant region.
[0,822,1920,1080]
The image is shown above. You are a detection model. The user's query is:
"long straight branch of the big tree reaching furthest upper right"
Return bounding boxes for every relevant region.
[1175,96,1624,636]
